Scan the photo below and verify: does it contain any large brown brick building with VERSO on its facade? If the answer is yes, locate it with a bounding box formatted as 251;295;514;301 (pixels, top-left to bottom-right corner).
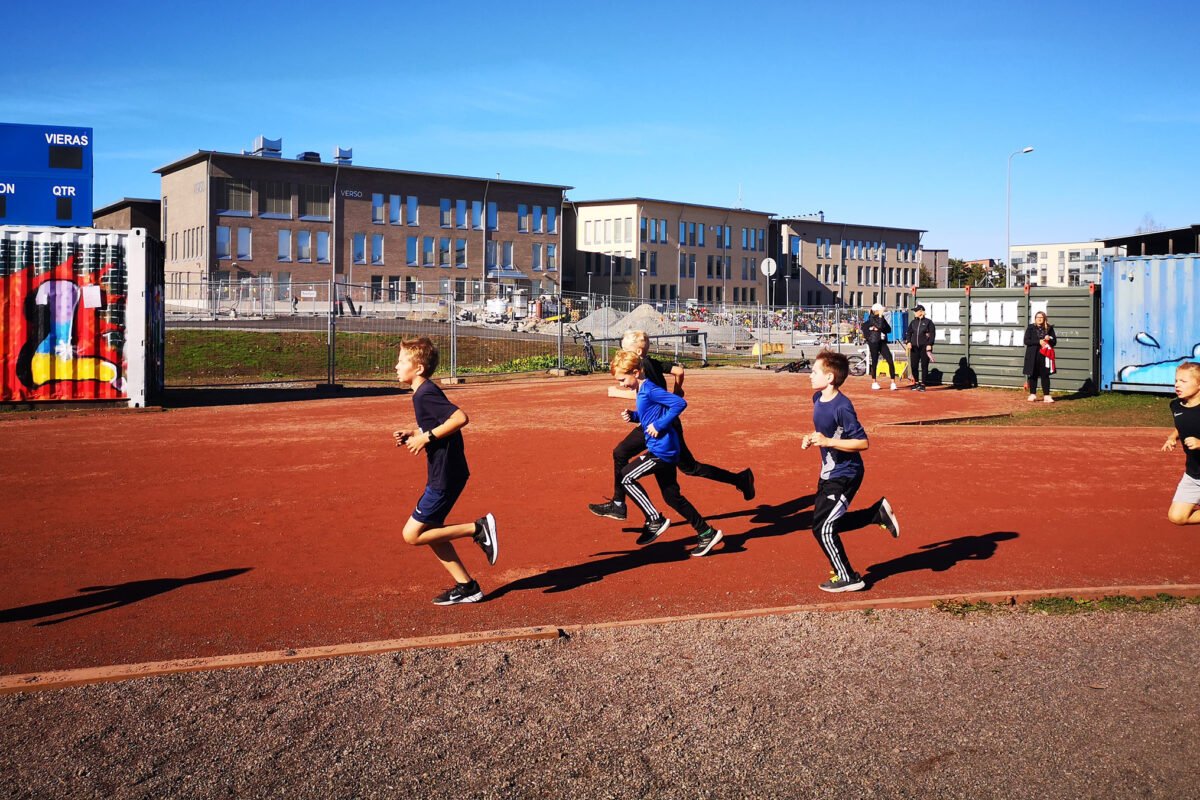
155;137;570;299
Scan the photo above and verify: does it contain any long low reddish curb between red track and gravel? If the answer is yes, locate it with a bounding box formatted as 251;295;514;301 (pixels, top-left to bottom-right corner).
0;583;1200;694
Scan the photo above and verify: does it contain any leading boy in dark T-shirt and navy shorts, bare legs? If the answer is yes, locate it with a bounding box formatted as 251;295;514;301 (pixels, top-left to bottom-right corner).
392;336;498;606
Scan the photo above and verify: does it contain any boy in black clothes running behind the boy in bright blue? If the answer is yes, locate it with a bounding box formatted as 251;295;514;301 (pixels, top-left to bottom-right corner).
588;331;755;519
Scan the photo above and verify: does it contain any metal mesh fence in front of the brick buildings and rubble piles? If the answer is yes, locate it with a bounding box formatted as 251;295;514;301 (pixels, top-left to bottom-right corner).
164;278;899;386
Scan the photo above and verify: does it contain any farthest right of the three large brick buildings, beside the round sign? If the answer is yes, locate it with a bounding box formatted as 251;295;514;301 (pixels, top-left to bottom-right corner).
770;212;925;308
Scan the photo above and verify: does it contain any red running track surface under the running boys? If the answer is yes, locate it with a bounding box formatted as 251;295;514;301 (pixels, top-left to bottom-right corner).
0;369;1200;674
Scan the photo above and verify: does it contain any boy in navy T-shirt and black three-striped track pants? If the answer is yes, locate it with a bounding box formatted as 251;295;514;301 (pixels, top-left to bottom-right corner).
800;350;900;591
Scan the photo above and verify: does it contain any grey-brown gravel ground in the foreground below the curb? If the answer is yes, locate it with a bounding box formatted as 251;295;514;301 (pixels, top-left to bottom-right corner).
0;606;1200;799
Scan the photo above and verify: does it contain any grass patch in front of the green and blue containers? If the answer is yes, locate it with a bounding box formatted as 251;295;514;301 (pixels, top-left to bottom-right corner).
947;389;1171;428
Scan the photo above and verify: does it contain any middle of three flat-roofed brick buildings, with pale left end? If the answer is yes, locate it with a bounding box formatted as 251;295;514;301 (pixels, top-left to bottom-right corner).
565;198;770;305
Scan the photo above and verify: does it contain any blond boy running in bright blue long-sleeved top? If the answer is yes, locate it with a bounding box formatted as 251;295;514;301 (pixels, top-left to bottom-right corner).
610;350;722;557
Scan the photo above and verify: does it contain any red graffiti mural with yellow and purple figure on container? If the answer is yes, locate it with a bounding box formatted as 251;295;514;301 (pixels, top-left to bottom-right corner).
0;254;126;401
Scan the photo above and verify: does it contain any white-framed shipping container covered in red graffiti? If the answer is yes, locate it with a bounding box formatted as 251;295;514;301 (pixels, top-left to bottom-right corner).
0;227;162;407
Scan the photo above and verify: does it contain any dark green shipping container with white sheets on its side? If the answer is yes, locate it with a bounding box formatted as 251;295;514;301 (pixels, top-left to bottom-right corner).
912;284;1100;393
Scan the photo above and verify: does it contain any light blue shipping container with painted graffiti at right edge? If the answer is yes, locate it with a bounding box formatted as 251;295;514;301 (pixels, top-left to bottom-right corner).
1100;253;1200;392
